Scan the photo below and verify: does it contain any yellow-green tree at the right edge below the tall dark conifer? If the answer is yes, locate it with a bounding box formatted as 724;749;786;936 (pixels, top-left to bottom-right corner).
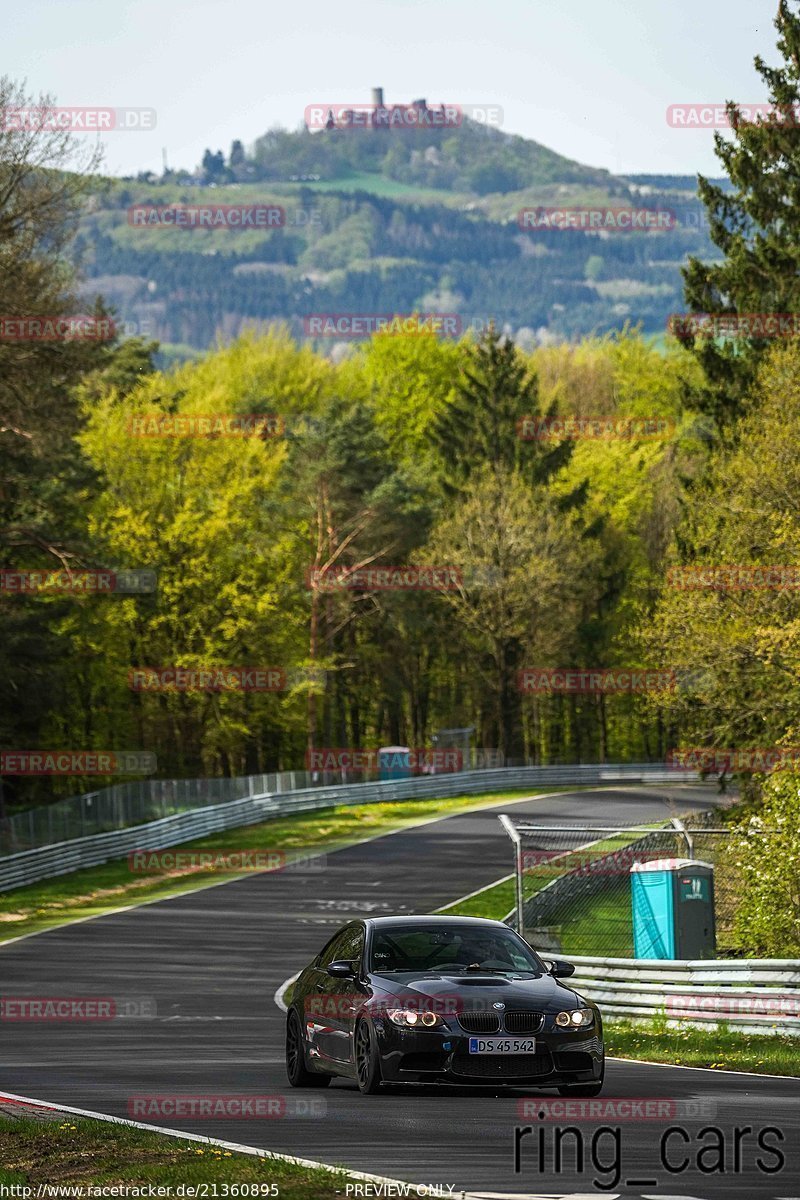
642;343;800;749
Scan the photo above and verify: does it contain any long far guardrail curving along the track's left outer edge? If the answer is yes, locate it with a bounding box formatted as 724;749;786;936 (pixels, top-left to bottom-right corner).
0;763;698;892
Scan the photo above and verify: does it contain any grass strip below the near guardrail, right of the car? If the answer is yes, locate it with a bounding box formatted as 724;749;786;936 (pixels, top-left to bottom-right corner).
603;1018;800;1076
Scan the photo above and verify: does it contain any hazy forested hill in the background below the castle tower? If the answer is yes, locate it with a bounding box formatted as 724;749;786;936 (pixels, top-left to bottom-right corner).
78;102;712;359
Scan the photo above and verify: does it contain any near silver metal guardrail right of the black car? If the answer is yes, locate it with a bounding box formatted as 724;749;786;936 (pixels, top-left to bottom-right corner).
568;952;800;1037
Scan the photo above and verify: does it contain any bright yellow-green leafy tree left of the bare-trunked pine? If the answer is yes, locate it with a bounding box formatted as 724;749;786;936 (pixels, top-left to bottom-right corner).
77;335;332;776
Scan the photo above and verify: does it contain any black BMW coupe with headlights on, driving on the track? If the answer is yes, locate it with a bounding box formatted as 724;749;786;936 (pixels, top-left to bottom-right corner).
287;917;604;1096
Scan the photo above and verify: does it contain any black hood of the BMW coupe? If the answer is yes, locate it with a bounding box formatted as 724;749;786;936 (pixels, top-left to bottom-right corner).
372;971;587;1010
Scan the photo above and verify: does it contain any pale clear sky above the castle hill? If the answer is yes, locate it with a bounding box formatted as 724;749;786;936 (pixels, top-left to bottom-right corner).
0;0;778;175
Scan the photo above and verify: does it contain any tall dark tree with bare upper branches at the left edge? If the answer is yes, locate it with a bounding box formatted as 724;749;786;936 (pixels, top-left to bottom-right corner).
0;78;113;816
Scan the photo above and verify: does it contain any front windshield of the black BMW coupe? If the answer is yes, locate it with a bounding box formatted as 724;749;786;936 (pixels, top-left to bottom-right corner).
369;924;545;974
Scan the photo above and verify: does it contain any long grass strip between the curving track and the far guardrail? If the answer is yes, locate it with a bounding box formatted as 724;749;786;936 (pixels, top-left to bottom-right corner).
0;788;563;943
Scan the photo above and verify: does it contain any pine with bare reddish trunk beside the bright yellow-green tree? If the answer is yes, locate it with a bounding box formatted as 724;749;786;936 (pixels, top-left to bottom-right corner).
285;400;429;749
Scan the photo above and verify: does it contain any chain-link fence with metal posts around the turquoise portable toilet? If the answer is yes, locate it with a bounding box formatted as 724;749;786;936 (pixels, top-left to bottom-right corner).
503;814;741;958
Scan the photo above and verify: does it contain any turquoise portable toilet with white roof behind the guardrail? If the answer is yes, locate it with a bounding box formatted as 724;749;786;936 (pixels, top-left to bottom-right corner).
631;858;716;959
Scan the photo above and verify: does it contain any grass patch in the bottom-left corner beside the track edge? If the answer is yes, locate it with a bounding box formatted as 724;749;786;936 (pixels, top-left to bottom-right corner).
0;1115;349;1200
